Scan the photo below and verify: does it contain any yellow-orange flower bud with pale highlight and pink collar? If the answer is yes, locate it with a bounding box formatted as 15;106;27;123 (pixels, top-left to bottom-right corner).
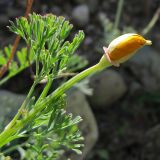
103;33;152;66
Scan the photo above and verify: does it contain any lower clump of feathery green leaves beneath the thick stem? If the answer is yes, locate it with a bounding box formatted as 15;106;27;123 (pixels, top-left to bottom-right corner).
20;96;83;160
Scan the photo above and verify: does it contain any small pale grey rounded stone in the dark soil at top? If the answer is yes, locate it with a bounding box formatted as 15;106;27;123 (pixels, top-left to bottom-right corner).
72;4;89;26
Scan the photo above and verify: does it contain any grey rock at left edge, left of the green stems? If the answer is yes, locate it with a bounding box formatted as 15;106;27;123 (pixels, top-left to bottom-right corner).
0;90;25;125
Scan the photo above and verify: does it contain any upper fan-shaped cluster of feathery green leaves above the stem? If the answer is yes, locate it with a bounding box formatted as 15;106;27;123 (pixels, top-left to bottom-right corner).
9;14;84;80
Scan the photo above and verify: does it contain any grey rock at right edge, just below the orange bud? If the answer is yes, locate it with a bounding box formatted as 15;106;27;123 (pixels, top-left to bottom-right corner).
126;47;160;91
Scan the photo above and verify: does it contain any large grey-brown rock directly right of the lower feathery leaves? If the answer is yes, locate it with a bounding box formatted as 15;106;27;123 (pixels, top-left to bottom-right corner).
67;89;98;160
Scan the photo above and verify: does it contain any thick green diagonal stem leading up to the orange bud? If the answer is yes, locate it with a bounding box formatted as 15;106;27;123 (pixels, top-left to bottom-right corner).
0;56;111;147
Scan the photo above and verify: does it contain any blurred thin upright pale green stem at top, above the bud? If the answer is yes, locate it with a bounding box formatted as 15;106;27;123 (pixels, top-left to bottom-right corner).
114;0;124;30
